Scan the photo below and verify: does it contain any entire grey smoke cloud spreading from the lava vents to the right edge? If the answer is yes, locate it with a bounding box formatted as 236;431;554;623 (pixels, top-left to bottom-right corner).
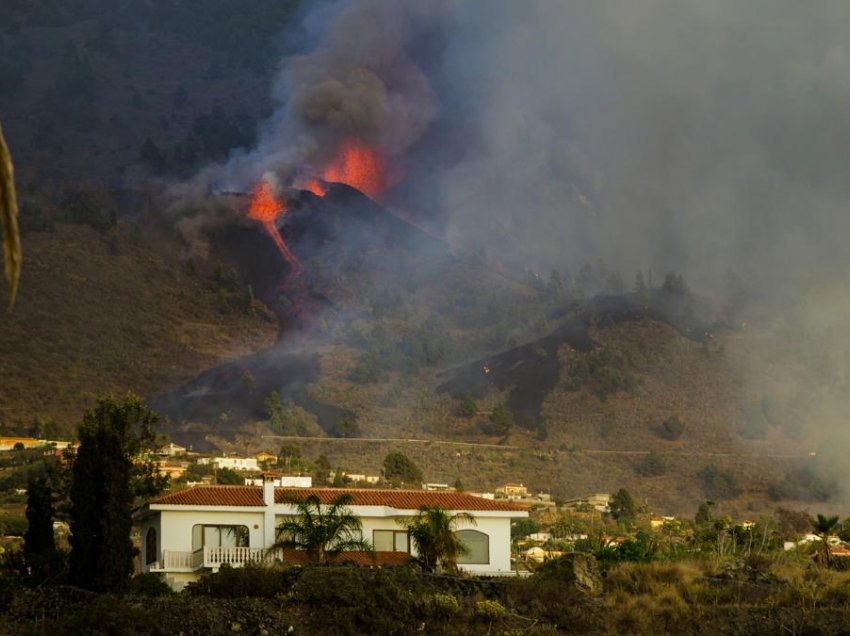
184;0;850;496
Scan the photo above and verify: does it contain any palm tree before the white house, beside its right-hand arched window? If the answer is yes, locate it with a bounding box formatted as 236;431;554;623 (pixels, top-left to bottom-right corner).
402;506;476;572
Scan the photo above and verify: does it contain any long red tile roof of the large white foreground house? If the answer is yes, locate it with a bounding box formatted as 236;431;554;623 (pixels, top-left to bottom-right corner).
151;486;528;511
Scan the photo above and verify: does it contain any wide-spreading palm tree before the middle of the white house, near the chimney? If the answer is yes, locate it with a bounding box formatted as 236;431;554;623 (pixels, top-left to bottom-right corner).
271;494;372;563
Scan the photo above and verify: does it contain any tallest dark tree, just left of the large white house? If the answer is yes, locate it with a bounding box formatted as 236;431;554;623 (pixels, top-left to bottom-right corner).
69;394;164;591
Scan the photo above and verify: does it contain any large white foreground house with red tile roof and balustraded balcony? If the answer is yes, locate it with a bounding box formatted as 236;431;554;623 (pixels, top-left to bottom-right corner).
137;482;528;589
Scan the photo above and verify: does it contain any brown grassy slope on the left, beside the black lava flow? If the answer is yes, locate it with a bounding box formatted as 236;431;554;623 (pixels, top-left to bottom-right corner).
0;220;275;430
